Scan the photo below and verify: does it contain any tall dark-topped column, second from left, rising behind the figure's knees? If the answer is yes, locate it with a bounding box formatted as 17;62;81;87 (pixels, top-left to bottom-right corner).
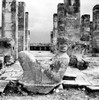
18;2;25;52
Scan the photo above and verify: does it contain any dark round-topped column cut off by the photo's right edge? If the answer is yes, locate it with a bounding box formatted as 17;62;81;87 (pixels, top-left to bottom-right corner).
92;5;99;53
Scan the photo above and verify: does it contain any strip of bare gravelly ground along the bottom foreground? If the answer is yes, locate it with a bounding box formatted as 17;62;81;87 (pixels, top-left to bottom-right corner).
0;89;99;100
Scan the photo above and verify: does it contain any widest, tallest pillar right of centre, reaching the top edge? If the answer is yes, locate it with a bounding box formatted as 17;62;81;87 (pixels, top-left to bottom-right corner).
64;0;80;41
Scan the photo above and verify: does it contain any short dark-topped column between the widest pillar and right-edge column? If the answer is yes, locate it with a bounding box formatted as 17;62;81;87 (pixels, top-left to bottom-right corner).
80;14;90;41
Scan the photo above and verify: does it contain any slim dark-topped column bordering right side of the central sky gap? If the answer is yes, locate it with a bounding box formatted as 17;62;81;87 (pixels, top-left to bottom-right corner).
53;13;58;53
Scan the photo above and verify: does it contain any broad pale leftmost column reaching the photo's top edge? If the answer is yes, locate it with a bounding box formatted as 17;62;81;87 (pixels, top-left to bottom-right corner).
1;0;18;59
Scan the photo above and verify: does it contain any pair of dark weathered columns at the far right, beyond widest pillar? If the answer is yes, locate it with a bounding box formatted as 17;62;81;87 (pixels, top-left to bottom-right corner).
81;5;99;53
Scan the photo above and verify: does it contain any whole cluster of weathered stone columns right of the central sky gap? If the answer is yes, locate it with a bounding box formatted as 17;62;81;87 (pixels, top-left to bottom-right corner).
51;0;99;52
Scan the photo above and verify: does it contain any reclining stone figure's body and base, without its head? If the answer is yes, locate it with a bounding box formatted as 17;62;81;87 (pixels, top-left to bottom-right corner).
19;42;69;93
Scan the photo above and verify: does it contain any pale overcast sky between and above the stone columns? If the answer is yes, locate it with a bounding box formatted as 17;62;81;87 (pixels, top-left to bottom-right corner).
0;0;99;43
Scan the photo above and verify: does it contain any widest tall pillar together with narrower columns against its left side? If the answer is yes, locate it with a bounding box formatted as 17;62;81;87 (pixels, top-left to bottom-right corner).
53;0;80;51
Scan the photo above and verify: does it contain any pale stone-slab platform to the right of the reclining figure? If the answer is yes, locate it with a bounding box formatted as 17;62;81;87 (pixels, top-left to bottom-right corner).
63;57;99;90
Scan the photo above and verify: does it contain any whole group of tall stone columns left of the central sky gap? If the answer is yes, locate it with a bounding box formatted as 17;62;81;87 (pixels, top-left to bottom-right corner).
1;0;30;59
